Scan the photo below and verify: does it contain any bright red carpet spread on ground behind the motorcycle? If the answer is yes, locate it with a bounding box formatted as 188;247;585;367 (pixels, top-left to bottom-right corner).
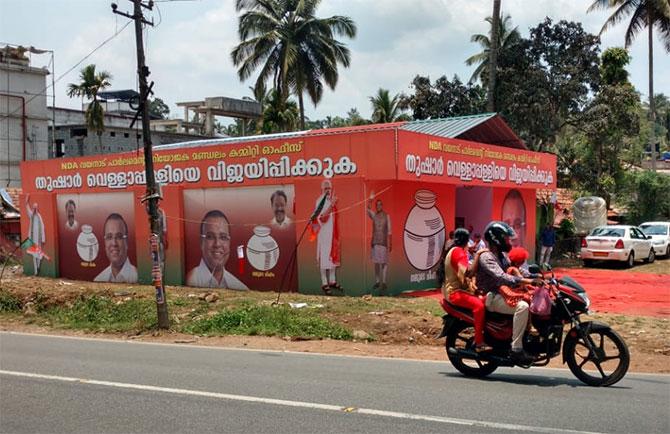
403;268;670;317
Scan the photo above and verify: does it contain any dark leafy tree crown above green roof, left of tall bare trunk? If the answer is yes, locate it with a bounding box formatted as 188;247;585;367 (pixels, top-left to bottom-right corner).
399;75;486;119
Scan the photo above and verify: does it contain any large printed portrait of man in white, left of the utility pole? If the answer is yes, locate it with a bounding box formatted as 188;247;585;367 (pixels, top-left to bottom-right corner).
93;213;137;283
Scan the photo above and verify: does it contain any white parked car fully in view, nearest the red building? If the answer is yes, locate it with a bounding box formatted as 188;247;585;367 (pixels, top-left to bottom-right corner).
580;225;656;267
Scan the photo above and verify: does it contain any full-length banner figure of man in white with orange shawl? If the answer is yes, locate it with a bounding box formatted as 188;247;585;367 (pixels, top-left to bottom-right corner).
312;179;342;295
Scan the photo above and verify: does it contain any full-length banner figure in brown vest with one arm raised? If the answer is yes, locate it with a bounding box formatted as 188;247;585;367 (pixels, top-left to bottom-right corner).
368;199;392;295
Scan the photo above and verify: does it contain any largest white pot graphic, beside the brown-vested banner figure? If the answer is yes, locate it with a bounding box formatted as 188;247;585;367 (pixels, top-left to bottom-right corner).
404;190;445;271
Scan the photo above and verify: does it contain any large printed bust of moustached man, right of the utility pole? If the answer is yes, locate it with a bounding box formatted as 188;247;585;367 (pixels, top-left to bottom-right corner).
186;210;249;290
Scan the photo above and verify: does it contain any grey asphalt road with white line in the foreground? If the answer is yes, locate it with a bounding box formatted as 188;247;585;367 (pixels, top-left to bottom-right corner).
0;333;670;433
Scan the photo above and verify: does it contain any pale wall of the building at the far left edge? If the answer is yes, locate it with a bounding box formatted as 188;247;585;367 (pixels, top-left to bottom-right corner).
0;62;49;187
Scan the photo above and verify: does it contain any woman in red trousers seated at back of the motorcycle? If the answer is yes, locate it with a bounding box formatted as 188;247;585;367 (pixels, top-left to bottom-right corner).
437;228;493;352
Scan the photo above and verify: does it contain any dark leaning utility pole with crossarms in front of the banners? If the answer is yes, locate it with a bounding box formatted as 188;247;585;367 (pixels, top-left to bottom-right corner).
112;0;170;329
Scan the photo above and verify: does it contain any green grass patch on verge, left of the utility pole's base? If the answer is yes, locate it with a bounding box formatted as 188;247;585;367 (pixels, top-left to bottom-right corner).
45;295;156;332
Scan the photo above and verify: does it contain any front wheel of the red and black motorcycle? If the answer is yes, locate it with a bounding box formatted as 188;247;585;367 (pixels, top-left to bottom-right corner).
563;325;630;387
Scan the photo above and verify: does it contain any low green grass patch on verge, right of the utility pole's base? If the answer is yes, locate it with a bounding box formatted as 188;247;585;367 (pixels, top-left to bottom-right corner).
183;304;353;340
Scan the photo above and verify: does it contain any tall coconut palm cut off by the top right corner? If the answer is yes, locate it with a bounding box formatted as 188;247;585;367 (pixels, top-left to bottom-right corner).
588;0;670;170
